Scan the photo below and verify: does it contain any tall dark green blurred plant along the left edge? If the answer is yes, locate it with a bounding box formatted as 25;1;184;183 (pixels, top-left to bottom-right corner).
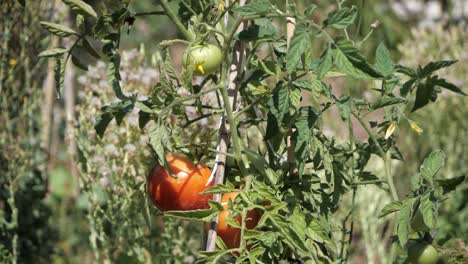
0;1;57;263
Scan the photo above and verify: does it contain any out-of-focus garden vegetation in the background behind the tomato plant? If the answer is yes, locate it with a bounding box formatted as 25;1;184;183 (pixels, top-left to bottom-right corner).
0;0;468;263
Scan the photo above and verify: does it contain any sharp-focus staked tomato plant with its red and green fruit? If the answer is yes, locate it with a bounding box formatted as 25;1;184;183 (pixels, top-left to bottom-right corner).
37;0;466;263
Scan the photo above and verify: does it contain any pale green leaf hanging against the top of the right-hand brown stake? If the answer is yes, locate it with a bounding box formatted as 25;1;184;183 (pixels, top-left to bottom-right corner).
286;24;311;73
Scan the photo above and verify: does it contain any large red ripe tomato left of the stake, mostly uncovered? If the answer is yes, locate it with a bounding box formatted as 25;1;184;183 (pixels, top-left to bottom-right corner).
148;153;214;211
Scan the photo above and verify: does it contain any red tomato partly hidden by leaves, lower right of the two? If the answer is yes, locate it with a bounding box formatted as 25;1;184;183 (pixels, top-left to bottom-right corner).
217;192;260;248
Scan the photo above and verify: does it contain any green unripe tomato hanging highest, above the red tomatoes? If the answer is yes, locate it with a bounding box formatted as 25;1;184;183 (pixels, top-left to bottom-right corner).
182;44;223;76
